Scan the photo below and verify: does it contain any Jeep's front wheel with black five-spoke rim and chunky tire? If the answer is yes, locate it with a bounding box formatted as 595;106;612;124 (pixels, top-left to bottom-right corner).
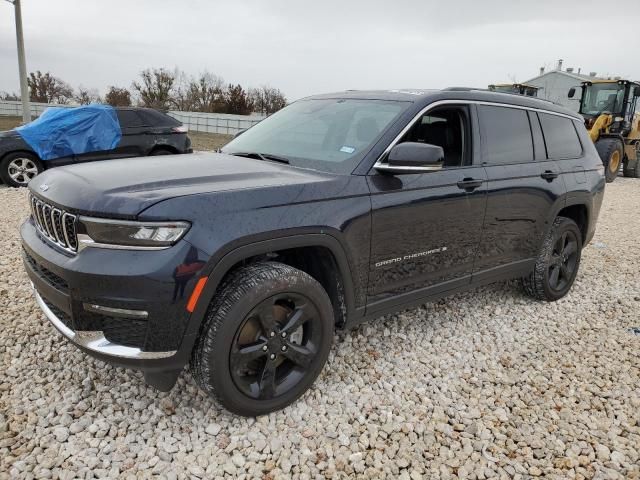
191;262;335;416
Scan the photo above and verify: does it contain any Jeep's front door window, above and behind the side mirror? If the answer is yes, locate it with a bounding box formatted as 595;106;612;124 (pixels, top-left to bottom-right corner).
398;107;471;168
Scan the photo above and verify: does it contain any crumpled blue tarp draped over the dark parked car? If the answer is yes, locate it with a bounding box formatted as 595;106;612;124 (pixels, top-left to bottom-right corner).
16;105;122;160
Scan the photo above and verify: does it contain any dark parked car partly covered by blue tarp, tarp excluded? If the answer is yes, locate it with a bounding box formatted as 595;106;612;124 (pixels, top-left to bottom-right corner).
0;107;193;187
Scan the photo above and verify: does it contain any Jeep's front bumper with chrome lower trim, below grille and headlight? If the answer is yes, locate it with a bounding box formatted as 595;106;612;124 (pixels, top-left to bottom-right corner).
21;219;204;376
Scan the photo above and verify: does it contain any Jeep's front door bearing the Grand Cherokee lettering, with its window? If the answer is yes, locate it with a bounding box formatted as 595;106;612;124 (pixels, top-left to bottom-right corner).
367;105;487;313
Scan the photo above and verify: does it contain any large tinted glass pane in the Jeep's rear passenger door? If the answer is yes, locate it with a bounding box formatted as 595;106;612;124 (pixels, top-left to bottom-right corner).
478;105;533;164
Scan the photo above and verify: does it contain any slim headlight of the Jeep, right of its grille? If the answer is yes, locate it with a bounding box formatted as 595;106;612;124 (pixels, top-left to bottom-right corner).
78;217;191;250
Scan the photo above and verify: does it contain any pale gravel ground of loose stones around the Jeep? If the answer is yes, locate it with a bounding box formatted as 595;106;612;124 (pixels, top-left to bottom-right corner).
0;178;640;480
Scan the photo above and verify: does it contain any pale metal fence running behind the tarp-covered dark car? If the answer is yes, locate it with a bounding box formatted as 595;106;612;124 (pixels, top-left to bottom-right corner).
0;100;265;135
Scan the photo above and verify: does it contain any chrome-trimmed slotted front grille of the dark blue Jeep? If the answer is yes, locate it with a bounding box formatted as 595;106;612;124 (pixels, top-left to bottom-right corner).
29;194;78;253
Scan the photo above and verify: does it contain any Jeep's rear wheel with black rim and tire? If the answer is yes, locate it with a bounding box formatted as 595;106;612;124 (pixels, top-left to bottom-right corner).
522;217;582;302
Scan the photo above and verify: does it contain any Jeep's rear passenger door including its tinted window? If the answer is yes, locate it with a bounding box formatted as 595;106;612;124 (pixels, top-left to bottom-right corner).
473;105;566;282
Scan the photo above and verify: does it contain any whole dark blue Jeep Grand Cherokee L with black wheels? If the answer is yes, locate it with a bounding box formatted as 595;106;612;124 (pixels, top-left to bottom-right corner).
21;89;605;415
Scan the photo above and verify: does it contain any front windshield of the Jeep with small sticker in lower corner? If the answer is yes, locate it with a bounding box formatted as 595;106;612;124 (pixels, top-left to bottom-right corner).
222;99;409;173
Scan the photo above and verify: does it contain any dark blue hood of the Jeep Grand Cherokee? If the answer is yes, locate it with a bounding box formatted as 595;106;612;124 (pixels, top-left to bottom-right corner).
29;152;327;218
